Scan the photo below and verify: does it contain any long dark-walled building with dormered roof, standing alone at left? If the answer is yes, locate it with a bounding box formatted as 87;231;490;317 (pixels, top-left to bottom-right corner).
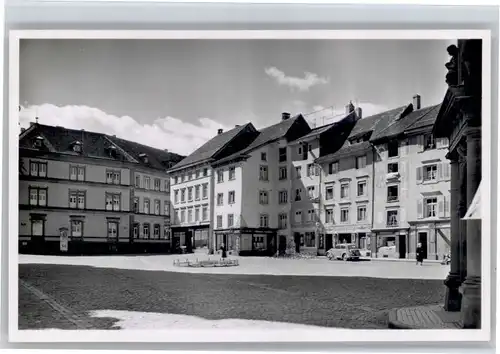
19;123;183;253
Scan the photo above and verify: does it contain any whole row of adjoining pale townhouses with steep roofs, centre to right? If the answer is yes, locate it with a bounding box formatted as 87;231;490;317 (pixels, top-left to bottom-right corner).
169;95;450;258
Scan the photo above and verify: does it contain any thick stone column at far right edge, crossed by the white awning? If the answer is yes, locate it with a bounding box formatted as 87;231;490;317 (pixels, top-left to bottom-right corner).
462;127;481;328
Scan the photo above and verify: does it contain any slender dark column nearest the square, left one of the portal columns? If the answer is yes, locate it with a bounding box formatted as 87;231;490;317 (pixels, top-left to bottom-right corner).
444;155;462;311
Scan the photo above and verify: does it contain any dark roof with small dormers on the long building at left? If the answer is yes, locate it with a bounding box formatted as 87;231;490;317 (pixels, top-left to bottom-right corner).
19;124;186;170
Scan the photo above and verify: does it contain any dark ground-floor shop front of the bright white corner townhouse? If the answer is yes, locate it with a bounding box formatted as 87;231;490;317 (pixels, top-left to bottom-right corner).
211;228;280;256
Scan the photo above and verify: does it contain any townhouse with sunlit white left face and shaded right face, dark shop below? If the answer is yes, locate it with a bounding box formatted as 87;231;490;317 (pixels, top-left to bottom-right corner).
208;113;311;255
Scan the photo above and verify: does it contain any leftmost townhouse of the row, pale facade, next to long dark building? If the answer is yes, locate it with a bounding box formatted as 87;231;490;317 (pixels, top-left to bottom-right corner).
169;123;257;252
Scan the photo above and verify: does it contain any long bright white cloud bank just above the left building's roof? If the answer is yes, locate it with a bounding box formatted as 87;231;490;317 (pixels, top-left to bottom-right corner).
19;103;231;155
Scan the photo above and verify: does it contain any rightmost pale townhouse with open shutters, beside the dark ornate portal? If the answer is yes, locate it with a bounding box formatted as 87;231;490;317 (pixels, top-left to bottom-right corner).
370;95;450;259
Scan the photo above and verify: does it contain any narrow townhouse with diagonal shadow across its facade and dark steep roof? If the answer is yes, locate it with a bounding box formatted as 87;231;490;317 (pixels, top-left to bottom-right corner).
290;104;361;255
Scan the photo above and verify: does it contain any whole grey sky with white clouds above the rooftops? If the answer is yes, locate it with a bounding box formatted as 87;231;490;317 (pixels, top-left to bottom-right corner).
20;39;449;154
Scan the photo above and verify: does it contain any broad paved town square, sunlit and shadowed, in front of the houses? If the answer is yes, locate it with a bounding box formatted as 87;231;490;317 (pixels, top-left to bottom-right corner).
19;255;449;329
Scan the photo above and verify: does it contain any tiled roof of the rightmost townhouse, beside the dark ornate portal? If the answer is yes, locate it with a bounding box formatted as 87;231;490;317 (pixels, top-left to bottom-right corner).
370;105;439;141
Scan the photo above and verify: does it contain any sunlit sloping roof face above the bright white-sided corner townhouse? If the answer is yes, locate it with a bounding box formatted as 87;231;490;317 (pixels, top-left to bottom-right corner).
210;114;307;167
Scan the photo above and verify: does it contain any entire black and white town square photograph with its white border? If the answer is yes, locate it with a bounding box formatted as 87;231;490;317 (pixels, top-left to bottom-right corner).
8;31;491;341
